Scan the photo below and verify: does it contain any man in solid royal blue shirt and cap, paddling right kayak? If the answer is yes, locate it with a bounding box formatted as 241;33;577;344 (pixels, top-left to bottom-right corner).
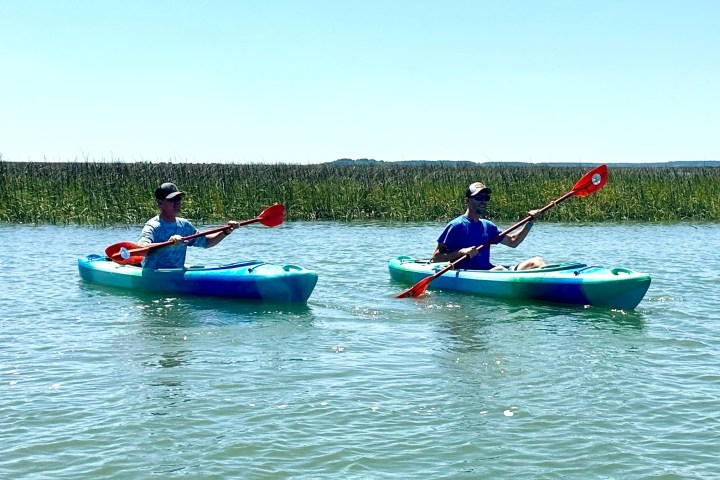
432;182;545;270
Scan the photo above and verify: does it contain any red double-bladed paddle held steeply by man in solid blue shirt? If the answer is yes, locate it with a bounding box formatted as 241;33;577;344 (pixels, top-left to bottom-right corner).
395;165;607;298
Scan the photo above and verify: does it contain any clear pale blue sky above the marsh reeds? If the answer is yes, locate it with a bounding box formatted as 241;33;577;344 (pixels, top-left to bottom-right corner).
0;0;720;163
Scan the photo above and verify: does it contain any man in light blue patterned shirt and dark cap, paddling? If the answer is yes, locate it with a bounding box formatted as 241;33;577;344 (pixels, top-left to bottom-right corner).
138;182;238;269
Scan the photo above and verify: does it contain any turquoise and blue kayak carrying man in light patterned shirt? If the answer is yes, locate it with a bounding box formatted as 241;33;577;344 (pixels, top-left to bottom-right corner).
78;254;318;303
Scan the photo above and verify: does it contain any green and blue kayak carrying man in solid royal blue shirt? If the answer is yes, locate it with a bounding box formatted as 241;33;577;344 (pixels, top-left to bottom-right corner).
388;256;651;310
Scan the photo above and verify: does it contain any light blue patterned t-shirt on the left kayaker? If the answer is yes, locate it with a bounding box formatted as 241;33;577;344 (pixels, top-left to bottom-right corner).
138;215;207;269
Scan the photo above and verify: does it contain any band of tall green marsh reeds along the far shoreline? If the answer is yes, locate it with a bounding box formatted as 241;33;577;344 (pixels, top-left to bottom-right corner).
0;157;720;226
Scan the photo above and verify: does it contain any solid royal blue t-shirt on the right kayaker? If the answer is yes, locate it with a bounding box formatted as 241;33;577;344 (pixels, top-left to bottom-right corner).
438;215;502;270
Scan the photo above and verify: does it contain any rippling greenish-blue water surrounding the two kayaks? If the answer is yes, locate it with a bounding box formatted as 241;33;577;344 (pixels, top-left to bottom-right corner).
0;223;720;479
